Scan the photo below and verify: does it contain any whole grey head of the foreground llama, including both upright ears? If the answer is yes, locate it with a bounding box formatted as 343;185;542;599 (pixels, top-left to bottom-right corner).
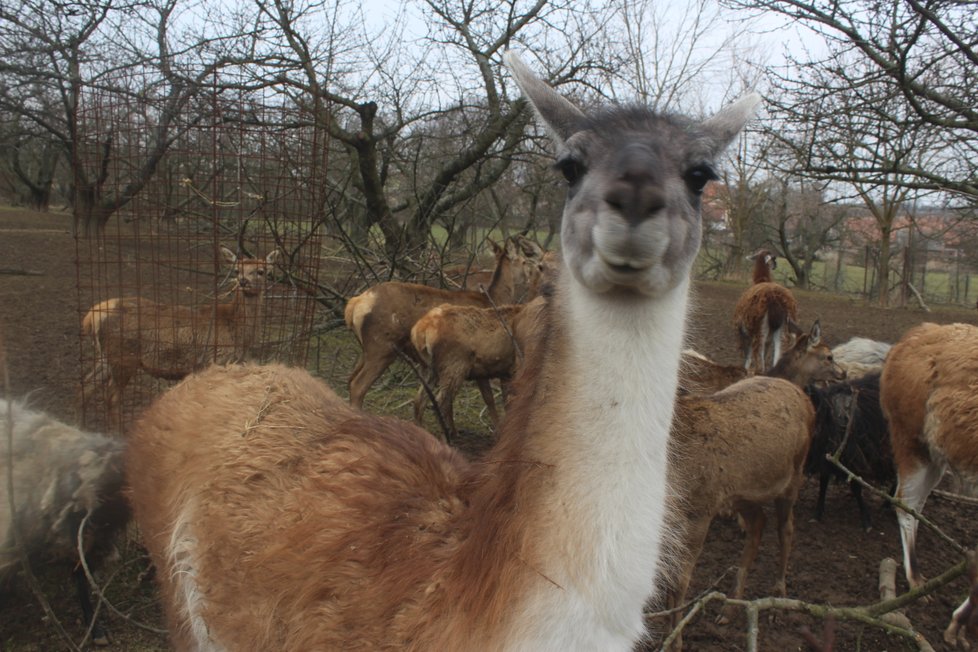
506;52;760;296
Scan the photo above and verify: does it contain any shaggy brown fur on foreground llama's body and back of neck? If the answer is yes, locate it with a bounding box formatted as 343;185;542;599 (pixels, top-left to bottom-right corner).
127;292;563;650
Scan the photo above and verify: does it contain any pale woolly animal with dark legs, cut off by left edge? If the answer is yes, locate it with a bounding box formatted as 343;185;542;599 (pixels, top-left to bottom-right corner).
0;400;129;644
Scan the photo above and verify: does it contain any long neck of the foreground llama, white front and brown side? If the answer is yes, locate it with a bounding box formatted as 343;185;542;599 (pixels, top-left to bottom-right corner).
472;279;687;649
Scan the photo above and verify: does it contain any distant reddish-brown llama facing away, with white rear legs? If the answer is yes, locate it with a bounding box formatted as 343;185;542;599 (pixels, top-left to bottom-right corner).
734;249;798;373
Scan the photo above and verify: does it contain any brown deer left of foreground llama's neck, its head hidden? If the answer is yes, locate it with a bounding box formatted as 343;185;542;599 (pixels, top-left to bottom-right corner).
411;297;545;441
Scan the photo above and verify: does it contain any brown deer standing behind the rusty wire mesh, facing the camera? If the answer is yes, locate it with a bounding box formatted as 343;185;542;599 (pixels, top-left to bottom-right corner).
82;247;279;422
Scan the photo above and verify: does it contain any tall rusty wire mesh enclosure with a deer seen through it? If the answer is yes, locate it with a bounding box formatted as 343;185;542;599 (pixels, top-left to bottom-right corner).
76;85;328;432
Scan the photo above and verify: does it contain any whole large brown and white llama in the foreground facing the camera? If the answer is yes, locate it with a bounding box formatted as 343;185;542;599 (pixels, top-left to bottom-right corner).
127;54;759;650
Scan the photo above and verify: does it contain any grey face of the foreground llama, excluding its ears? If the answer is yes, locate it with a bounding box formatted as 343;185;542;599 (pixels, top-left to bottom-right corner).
557;114;715;296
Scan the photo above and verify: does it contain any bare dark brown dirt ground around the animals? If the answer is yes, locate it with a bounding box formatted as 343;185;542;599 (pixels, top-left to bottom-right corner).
0;208;978;652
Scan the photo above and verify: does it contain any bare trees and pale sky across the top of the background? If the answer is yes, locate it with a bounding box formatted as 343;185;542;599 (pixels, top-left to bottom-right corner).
0;0;978;304
